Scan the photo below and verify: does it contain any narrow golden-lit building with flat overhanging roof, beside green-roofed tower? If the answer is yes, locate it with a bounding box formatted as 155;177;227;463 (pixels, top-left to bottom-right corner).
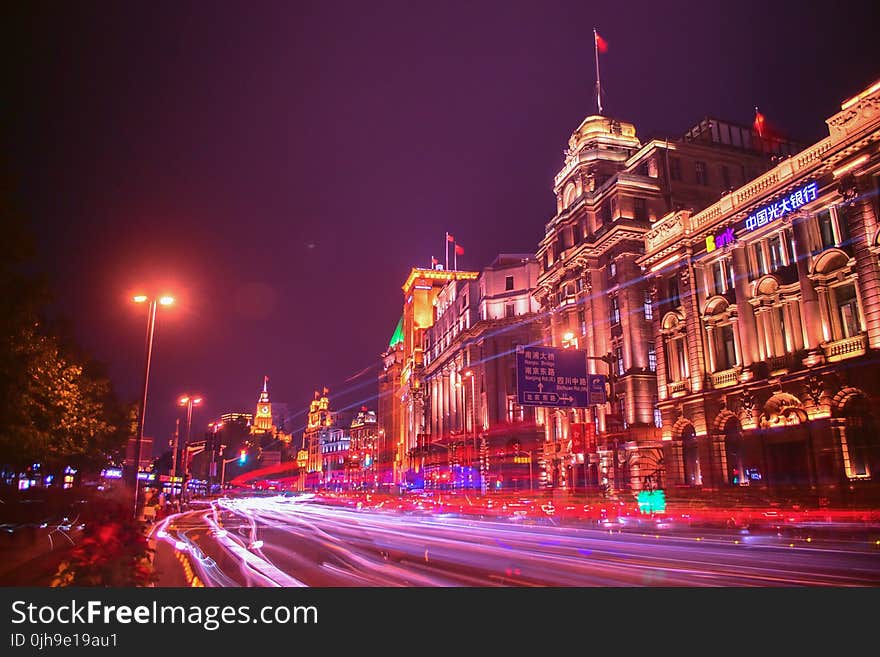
386;268;477;484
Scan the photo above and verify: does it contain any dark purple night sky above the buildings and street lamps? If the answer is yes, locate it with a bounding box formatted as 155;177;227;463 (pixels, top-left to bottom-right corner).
0;0;880;448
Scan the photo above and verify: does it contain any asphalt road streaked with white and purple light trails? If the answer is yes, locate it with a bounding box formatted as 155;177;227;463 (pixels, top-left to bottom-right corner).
154;497;880;587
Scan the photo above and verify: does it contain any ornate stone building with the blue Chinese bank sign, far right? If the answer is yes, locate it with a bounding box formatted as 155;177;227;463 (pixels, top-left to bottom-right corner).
639;78;880;497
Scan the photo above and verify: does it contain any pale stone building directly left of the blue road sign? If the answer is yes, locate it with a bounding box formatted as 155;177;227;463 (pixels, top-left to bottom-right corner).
422;254;542;489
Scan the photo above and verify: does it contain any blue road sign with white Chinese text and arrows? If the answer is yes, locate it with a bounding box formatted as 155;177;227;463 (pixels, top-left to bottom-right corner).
516;347;605;408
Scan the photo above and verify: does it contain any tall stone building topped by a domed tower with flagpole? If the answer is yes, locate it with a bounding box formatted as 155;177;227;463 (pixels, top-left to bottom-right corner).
535;111;797;489
